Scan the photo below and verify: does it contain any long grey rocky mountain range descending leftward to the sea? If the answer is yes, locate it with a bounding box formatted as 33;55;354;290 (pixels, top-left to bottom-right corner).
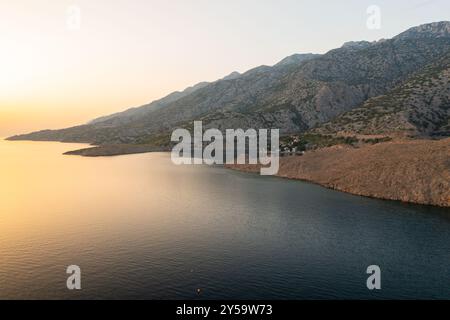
6;22;450;145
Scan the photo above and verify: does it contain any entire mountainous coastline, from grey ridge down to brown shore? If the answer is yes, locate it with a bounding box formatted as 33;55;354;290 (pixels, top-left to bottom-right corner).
8;21;450;207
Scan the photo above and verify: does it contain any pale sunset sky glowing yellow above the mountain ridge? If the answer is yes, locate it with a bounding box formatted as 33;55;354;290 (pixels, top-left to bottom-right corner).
0;0;450;137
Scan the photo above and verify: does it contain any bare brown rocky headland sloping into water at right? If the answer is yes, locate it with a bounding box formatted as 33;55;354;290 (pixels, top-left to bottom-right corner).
230;139;450;207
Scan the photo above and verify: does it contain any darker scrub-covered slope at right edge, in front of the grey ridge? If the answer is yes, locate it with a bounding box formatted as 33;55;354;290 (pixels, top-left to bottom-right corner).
313;53;450;137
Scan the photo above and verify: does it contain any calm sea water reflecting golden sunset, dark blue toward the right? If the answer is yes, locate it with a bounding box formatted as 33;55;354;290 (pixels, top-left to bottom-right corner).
0;141;450;299
